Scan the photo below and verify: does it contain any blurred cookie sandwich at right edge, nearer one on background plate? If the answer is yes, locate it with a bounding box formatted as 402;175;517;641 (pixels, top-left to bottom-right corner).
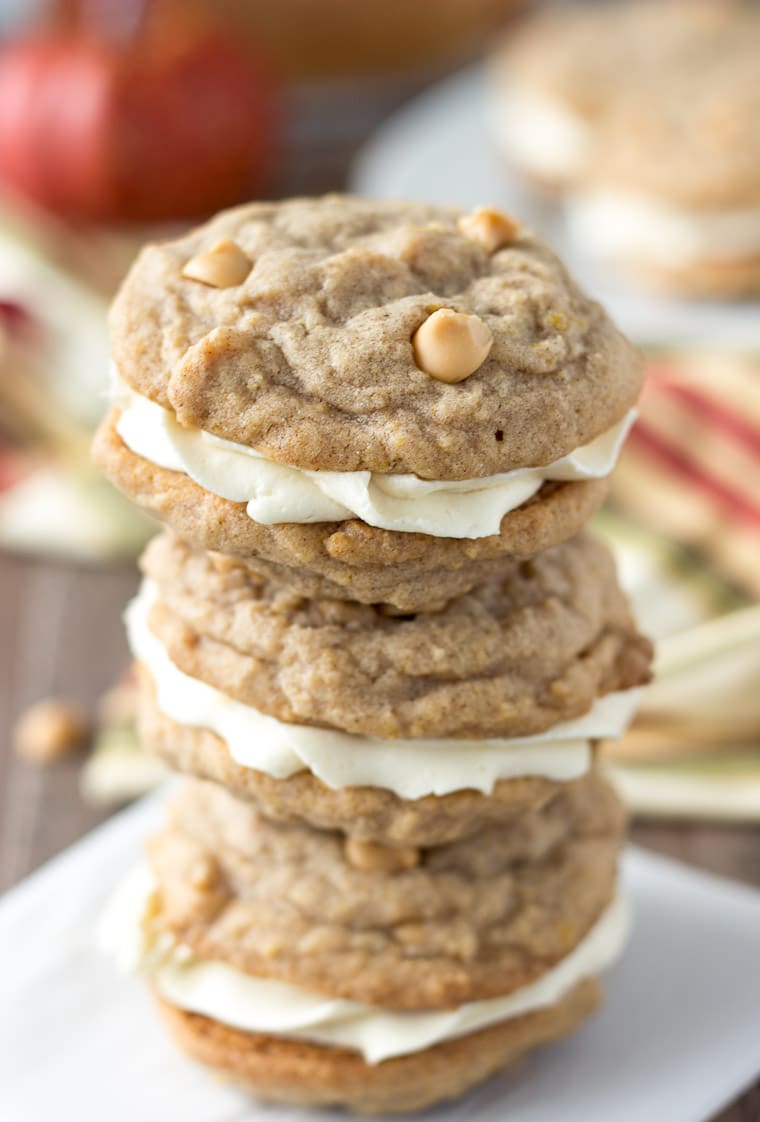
567;19;760;297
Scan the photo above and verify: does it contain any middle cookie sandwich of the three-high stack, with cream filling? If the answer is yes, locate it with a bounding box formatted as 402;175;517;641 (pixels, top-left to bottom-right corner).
127;533;651;846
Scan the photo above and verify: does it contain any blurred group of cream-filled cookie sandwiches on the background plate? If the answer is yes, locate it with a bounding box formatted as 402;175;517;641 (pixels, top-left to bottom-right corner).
491;0;760;297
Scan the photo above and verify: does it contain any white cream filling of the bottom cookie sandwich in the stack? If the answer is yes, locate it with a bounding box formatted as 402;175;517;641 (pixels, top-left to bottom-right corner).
98;866;630;1064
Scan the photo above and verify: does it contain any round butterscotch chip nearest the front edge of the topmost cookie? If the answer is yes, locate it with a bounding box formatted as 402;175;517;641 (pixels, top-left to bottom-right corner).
412;307;494;383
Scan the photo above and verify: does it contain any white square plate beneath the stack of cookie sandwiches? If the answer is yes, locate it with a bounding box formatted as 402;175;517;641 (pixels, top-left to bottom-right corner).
0;797;760;1122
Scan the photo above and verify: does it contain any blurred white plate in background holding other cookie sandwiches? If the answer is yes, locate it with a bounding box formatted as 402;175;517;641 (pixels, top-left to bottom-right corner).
351;66;760;347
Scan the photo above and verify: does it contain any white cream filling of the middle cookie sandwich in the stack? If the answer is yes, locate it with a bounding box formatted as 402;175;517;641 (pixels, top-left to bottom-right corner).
125;580;639;799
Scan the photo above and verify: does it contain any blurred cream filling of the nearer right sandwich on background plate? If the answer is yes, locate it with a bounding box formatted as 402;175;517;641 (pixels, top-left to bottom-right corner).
567;191;760;267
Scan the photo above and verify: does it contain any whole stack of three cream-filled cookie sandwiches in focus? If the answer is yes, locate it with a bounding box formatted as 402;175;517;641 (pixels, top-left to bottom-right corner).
95;196;651;1112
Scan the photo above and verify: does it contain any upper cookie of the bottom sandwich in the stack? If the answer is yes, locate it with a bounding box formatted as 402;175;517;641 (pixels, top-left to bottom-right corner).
143;774;623;1010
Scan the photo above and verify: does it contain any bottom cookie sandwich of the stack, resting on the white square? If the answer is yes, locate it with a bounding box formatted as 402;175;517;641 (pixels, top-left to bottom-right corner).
101;776;628;1113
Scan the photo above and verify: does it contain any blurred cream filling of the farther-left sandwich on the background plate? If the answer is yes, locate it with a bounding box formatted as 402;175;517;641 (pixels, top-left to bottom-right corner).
489;82;592;180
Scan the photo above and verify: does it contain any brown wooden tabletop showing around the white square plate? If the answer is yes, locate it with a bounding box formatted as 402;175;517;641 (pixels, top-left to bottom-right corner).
0;554;760;1122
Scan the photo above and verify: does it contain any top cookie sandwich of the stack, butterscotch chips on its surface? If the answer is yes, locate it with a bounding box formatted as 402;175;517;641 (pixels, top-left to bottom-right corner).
94;196;641;604
